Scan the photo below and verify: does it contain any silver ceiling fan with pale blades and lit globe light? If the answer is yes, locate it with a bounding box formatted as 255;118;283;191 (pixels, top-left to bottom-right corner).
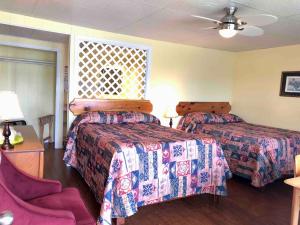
192;6;278;38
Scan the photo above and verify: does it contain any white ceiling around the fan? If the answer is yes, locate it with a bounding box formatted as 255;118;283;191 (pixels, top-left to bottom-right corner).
0;0;300;51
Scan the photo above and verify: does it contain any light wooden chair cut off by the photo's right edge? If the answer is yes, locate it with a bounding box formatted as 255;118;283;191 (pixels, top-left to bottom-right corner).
284;155;300;225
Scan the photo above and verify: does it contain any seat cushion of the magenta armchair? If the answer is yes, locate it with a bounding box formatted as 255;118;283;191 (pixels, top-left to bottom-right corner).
28;188;96;225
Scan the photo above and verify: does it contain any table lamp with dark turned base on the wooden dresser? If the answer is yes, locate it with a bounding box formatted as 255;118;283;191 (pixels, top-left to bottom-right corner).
0;91;24;150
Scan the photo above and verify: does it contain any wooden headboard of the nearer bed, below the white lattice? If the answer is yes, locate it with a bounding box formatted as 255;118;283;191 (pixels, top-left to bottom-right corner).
69;98;153;116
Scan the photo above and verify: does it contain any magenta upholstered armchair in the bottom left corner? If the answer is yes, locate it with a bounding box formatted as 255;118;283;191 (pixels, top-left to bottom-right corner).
0;151;96;225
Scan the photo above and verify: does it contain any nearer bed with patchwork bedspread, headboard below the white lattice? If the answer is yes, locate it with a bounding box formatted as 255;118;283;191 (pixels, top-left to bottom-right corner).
64;99;231;225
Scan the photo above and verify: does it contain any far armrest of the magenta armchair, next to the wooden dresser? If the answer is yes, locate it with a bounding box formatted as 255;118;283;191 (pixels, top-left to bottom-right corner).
0;154;62;200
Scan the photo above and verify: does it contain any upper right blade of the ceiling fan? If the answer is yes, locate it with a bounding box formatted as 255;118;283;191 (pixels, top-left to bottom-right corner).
239;14;278;27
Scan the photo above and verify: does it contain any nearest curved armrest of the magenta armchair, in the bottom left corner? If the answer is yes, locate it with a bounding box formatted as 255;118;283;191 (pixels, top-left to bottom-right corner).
0;181;76;225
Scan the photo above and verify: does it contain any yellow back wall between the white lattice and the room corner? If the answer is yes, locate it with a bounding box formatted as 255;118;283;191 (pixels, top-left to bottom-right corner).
148;42;234;124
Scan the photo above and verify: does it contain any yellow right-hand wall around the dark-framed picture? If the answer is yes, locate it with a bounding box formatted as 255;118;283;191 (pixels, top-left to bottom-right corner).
232;45;300;131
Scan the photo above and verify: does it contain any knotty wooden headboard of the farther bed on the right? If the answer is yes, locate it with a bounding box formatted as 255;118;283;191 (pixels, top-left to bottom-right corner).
176;102;231;116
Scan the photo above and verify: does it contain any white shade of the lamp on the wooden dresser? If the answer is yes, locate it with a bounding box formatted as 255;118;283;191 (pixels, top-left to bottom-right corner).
0;91;24;121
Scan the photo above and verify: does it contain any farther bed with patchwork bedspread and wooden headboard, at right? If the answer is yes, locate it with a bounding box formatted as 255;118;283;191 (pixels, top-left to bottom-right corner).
176;102;300;187
